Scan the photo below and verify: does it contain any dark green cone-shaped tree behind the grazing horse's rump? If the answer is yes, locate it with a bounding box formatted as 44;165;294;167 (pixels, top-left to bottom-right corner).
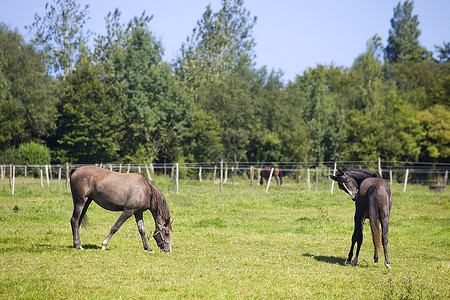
56;55;124;163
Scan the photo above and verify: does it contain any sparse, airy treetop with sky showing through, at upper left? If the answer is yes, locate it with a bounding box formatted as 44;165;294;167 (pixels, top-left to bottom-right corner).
26;0;89;80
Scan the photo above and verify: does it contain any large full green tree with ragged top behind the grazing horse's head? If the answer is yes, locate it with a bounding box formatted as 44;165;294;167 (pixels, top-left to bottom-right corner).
95;10;192;162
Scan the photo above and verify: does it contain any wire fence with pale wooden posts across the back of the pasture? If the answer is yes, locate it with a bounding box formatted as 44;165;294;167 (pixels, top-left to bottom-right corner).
0;160;450;194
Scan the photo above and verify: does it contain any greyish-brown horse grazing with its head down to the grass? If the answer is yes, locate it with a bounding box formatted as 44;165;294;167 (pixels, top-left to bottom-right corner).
70;166;172;252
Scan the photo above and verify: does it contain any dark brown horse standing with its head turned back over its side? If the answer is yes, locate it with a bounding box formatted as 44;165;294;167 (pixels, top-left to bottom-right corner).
330;168;392;268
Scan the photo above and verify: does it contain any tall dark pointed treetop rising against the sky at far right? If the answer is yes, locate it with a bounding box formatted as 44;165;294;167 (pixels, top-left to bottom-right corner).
386;0;431;63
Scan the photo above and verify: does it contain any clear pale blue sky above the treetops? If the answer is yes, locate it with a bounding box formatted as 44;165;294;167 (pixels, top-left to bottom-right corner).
0;0;450;80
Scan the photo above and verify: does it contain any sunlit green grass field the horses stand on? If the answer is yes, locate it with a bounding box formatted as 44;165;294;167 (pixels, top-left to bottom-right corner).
0;178;450;299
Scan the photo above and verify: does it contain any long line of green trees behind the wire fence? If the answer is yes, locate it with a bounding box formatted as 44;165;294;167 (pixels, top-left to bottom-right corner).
0;0;450;163
